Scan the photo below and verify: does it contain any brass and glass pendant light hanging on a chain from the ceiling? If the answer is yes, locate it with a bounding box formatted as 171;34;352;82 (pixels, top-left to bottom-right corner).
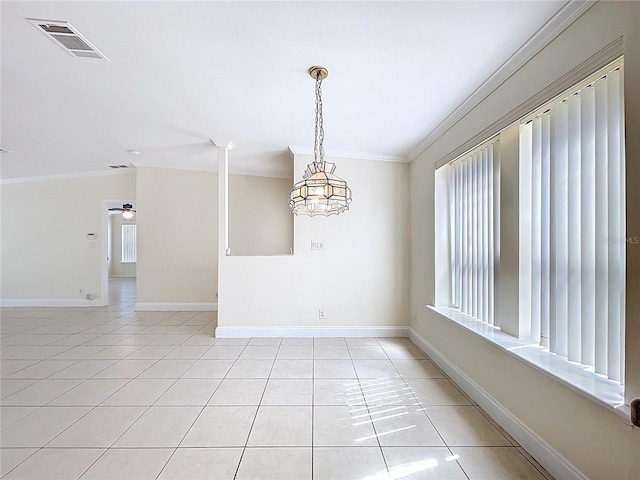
289;67;351;217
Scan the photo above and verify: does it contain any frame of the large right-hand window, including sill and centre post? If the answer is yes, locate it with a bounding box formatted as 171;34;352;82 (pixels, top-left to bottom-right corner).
427;53;630;424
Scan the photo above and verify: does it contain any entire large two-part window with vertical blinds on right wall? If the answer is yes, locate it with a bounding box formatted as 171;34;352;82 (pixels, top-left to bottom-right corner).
435;59;626;384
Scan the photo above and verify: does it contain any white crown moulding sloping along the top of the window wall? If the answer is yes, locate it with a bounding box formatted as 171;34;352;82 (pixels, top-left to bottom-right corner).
407;0;596;161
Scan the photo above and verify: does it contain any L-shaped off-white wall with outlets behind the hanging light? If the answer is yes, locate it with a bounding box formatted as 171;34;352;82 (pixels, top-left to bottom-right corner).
218;152;409;330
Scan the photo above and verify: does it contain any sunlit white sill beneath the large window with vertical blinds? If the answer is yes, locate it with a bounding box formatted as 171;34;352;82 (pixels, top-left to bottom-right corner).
427;305;631;425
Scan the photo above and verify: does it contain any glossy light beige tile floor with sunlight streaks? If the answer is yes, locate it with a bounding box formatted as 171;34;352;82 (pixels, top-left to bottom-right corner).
0;280;551;480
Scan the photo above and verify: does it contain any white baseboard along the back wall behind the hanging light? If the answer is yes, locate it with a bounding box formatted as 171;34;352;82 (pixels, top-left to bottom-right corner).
216;326;409;338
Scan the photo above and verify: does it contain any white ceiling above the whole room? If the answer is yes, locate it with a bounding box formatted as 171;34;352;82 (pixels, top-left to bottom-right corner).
0;0;568;180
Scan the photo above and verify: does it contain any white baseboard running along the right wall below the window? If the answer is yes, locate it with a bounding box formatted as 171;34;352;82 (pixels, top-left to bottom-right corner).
409;328;587;480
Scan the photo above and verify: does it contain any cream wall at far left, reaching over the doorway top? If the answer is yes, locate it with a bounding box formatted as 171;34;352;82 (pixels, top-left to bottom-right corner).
0;174;136;301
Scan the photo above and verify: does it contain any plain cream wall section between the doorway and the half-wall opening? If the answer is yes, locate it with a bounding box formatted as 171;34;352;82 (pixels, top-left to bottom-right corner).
136;167;218;309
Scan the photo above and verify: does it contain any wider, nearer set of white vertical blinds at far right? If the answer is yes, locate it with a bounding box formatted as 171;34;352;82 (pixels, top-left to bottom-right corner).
521;62;626;382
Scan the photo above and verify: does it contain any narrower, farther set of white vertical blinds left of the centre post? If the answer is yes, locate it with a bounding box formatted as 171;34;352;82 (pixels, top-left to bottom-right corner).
448;140;498;325
